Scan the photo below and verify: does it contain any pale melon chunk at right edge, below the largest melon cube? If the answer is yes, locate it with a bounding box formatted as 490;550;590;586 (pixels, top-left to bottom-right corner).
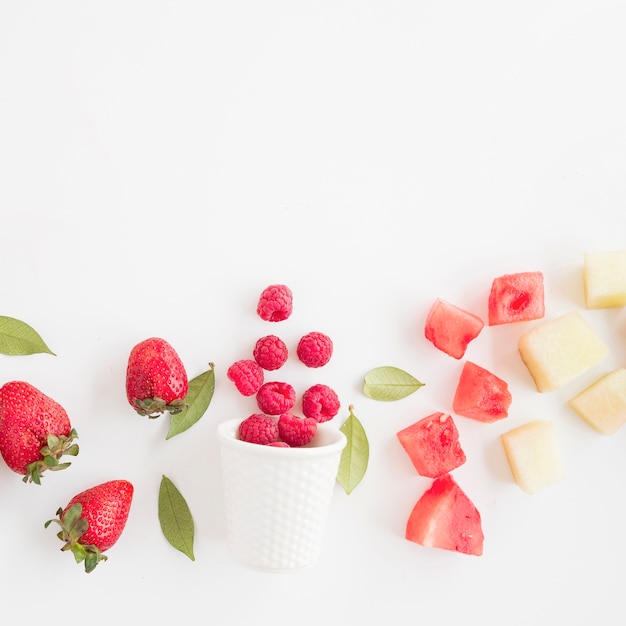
568;367;626;435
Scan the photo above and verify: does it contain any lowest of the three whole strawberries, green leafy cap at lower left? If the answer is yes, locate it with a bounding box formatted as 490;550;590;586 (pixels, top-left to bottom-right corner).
44;480;134;573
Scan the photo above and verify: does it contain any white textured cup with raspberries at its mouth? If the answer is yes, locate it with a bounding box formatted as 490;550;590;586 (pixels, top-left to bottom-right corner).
218;419;346;571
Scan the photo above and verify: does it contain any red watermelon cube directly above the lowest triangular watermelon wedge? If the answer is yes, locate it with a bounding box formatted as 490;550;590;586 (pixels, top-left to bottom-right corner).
396;411;466;478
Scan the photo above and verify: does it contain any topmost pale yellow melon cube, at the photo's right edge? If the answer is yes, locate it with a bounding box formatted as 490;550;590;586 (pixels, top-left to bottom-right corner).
583;250;626;309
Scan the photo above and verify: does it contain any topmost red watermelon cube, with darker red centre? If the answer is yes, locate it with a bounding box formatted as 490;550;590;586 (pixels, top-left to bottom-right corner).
488;272;545;326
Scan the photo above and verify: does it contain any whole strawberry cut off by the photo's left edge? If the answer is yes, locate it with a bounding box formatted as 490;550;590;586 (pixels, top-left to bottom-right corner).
0;381;78;485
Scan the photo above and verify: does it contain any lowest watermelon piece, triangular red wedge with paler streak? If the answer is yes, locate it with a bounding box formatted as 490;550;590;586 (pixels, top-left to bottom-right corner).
405;474;484;556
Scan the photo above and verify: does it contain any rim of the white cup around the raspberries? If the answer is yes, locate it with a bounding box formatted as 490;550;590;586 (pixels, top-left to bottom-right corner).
217;418;348;458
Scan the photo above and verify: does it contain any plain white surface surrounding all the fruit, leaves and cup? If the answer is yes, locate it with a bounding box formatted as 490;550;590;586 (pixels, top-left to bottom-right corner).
0;0;626;625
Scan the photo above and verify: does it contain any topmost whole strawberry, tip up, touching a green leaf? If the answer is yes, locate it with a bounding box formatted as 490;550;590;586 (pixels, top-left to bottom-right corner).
126;337;189;417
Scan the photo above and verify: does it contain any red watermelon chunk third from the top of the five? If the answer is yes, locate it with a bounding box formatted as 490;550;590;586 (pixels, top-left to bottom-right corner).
452;361;512;422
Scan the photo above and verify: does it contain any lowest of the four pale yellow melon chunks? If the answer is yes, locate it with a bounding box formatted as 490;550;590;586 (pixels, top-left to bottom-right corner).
500;420;564;494
